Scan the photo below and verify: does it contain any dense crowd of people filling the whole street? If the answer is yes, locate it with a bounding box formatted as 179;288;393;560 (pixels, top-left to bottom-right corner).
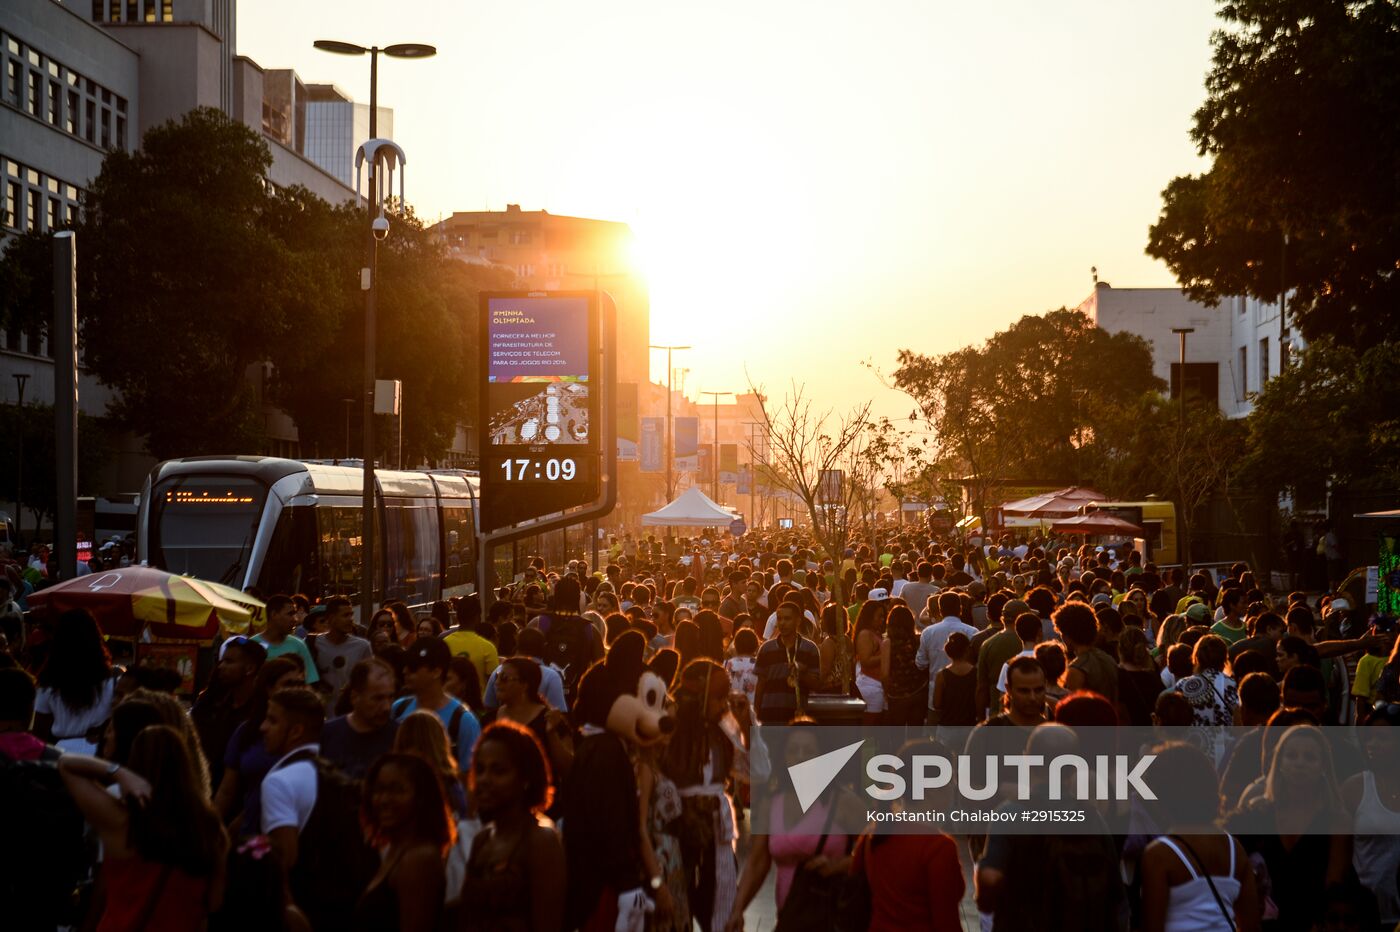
0;529;1400;932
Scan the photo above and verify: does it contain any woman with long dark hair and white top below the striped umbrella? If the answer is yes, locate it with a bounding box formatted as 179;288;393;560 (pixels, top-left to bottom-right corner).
34;610;116;754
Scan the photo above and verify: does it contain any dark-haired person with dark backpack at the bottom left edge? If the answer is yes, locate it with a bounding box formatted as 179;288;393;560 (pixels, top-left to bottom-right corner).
0;668;97;932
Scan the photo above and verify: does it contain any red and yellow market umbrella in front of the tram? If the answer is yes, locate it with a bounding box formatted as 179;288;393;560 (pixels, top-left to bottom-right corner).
29;567;252;641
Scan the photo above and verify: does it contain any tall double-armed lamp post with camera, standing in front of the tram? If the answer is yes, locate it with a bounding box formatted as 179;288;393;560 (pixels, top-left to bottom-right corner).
312;39;437;623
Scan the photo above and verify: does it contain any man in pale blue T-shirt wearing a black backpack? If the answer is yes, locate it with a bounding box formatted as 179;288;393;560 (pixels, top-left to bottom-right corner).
262;687;378;932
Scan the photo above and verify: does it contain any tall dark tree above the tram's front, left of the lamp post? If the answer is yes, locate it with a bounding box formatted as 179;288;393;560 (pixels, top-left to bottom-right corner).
78;108;307;459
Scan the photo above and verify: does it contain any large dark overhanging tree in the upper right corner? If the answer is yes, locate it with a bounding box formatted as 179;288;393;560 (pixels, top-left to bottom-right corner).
1147;0;1400;348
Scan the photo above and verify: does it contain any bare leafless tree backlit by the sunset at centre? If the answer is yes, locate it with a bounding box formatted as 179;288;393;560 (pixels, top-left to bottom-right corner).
749;382;871;563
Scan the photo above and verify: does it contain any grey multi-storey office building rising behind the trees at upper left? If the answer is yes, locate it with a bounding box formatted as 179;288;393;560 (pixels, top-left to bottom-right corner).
0;0;386;490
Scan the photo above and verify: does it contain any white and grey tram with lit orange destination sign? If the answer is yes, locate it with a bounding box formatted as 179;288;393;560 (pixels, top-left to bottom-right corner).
137;456;480;606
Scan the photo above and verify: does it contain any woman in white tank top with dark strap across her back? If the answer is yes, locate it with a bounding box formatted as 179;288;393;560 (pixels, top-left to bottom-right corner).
1138;743;1260;932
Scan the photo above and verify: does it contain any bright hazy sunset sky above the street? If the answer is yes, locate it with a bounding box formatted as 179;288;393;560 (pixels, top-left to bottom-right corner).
238;0;1215;414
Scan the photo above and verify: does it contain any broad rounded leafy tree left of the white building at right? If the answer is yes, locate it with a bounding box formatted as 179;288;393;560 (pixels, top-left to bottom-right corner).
893;308;1163;514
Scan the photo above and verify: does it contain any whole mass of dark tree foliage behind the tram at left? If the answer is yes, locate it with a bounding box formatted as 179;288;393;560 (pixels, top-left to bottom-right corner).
0;109;511;463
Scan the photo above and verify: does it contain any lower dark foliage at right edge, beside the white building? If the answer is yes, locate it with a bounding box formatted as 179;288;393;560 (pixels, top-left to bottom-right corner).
1246;340;1400;504
